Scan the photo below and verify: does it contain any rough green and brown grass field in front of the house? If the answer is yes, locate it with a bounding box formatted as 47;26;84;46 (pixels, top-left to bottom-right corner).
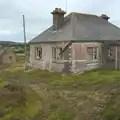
0;55;120;120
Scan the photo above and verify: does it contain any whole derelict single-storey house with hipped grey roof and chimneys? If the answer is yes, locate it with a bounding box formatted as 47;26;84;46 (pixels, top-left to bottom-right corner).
29;8;120;73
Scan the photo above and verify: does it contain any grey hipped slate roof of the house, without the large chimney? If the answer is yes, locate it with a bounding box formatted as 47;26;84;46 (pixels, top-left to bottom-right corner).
30;12;120;43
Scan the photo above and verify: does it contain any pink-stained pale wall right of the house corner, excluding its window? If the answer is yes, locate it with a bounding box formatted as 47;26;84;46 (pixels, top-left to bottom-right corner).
72;42;102;73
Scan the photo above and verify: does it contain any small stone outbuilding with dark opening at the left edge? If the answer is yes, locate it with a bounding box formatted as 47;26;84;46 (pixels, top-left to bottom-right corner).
0;47;16;65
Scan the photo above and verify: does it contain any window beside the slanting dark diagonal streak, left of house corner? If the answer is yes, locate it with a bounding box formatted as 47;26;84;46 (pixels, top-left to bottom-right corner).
52;47;62;60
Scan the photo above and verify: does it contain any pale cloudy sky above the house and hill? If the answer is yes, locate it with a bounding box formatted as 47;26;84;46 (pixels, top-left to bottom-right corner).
0;0;120;42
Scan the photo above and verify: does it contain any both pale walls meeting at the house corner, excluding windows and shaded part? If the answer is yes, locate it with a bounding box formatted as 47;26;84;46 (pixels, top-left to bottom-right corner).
30;42;102;73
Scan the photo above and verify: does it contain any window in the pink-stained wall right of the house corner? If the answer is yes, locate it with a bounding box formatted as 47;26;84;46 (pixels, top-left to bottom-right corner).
87;47;98;60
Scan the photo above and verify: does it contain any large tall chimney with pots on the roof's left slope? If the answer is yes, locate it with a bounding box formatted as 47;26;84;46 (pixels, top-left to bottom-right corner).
51;8;66;30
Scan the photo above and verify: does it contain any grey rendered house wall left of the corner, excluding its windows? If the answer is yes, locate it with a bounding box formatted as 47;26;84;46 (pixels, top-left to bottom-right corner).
30;42;68;72
